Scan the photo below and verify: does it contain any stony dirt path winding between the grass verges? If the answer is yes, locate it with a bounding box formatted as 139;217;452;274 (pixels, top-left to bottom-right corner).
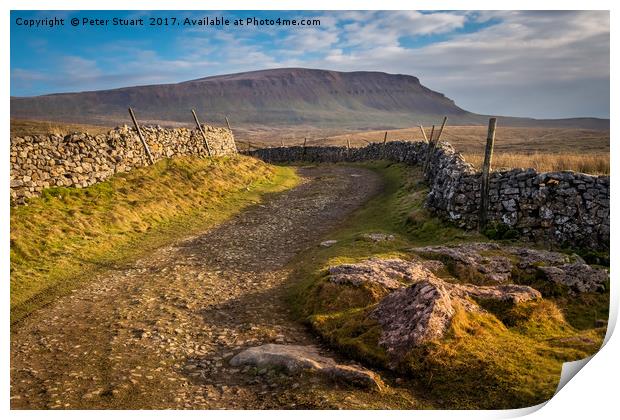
11;166;392;408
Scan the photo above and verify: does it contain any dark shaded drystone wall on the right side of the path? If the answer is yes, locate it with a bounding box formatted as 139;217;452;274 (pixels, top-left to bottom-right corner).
250;141;610;250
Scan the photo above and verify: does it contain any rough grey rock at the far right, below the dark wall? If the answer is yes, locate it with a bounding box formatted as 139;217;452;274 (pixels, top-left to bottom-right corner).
538;262;609;292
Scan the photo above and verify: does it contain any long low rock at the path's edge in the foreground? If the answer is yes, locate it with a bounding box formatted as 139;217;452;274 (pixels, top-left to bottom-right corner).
230;344;383;391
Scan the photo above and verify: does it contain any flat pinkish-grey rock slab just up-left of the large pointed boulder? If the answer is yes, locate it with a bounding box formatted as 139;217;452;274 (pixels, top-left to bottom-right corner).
329;258;434;290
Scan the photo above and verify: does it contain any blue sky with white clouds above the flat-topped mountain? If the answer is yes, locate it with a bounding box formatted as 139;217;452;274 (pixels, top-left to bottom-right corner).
10;11;610;118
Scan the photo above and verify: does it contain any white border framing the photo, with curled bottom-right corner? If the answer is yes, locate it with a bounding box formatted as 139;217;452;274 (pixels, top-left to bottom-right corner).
0;0;620;420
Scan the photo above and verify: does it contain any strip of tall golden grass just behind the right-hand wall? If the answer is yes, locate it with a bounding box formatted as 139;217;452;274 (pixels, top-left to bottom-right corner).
463;153;609;175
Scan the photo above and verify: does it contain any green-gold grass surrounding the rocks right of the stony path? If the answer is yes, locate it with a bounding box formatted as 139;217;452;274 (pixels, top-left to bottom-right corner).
290;163;609;409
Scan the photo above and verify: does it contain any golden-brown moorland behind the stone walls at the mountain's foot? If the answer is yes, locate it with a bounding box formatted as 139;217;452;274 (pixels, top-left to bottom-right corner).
11;119;610;175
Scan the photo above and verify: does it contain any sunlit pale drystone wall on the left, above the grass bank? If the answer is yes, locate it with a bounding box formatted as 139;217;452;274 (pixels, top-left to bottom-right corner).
11;125;237;204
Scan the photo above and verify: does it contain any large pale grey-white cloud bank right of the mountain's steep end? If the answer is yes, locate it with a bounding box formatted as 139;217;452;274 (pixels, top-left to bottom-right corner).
312;12;609;117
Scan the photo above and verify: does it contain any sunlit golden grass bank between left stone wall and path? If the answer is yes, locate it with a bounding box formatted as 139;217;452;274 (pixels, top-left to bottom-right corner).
11;155;298;322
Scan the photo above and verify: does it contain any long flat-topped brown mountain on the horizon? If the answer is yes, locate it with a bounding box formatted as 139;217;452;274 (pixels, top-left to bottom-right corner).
11;68;609;129
